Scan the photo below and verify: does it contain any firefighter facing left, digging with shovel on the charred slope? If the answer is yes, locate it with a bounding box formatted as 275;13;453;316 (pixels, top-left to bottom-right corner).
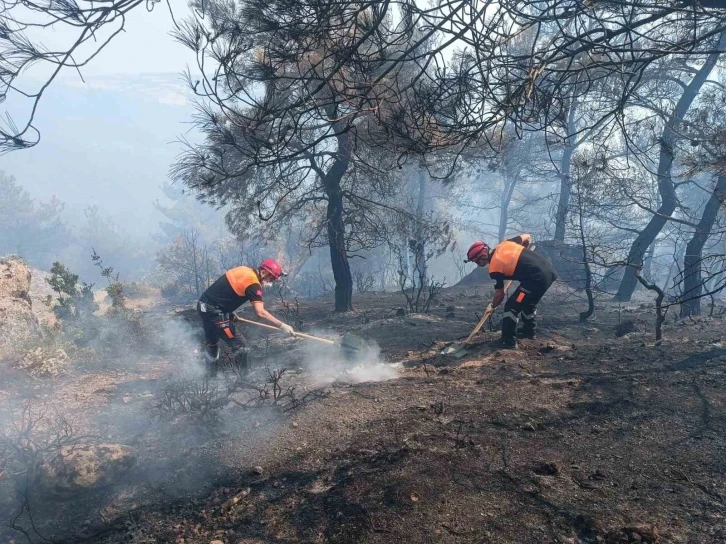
466;234;557;349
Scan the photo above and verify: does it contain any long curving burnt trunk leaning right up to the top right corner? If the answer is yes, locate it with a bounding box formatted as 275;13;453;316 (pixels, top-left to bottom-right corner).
615;33;726;301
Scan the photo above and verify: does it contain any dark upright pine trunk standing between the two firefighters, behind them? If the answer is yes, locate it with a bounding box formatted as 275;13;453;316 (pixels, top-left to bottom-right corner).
323;133;353;312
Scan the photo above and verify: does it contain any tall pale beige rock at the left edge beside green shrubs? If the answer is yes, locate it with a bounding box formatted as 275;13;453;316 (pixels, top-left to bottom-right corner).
0;257;40;360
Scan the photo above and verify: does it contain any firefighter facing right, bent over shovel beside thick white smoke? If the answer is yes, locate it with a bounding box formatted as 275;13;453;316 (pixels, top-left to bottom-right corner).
197;259;295;374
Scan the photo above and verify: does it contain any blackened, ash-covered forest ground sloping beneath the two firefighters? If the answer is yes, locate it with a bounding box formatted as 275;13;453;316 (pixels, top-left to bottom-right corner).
3;290;726;544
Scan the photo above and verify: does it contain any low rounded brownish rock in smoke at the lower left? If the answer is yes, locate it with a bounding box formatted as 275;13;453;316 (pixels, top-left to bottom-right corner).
37;444;138;495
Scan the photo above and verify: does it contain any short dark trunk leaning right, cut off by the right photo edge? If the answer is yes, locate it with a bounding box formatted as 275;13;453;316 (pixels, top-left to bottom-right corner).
681;176;726;317
